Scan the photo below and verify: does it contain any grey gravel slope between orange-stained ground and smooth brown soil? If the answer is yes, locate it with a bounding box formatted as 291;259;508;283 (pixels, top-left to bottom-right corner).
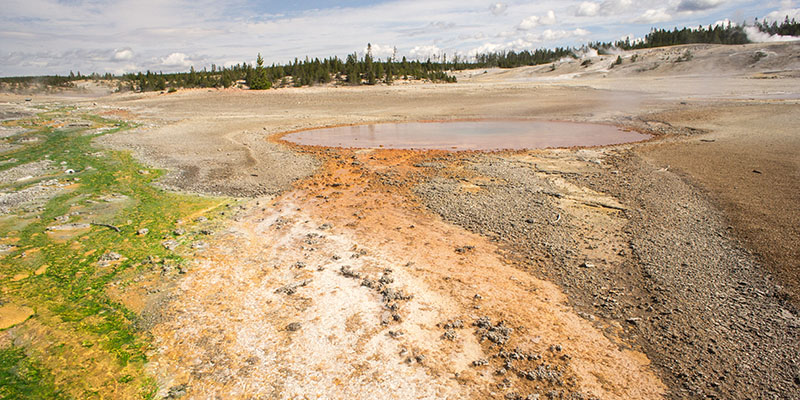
416;150;800;399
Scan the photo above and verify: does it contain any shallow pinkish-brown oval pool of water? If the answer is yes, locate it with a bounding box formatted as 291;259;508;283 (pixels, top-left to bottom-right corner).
283;120;650;150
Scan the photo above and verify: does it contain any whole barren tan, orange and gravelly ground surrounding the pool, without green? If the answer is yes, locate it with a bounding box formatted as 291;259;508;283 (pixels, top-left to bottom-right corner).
5;43;800;399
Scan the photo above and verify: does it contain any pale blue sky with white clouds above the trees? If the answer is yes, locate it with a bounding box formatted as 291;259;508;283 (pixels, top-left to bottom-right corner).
0;0;800;76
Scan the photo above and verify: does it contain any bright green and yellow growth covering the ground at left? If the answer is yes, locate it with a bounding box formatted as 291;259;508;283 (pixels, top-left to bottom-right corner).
0;107;230;398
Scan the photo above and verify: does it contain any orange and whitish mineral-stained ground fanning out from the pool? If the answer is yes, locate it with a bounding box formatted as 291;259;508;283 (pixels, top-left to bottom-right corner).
147;152;665;399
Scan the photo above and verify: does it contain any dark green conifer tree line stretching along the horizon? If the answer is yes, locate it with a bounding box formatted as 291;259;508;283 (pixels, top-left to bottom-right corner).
0;16;800;92
